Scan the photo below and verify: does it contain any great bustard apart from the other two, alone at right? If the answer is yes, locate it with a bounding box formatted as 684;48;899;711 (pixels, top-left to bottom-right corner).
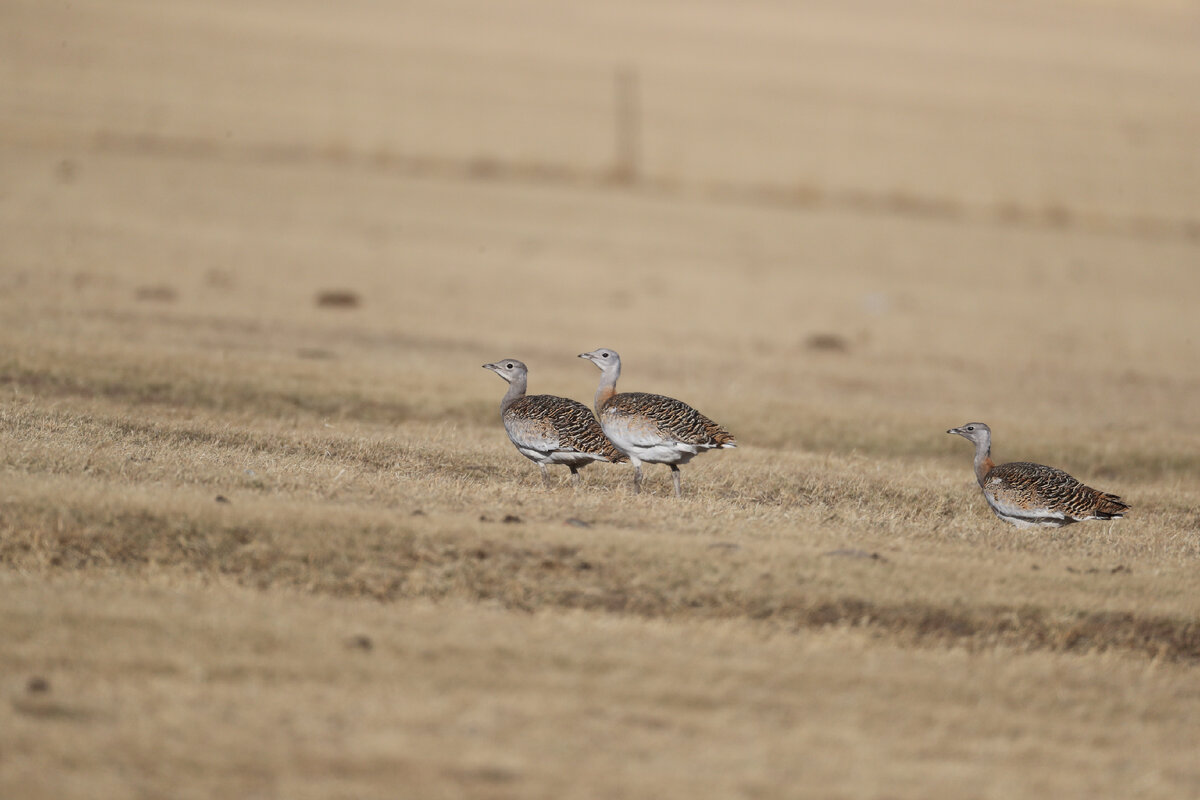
947;422;1129;528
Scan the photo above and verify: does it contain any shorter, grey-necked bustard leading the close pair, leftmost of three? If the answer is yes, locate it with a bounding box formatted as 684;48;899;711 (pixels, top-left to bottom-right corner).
484;359;625;488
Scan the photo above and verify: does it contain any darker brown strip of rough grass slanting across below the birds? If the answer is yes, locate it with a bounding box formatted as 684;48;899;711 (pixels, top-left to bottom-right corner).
0;499;1200;662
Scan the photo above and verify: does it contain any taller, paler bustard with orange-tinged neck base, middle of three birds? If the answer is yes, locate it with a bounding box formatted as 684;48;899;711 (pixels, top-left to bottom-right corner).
580;349;737;498
